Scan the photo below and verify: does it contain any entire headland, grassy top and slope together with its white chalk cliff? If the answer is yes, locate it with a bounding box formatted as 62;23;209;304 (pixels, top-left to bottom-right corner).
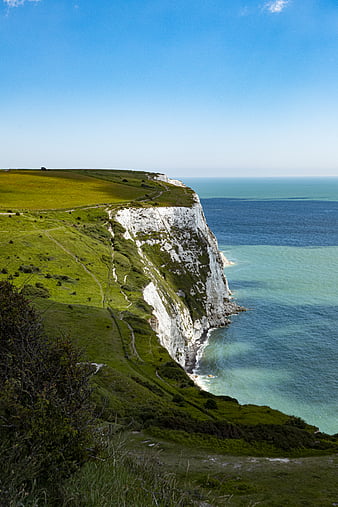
0;169;337;457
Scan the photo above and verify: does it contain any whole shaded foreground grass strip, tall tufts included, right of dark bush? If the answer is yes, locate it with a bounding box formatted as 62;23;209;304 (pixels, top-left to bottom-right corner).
59;432;338;507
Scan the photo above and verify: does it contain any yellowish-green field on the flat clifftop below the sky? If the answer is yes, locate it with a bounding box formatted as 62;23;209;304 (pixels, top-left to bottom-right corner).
0;170;192;211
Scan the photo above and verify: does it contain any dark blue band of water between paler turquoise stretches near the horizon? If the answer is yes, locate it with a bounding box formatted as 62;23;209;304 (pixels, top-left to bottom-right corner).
202;198;338;247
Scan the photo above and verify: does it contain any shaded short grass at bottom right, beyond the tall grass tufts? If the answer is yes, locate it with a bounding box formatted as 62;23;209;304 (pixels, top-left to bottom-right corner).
119;433;338;507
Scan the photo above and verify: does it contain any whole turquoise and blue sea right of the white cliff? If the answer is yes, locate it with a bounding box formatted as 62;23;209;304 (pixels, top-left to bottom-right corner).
183;178;338;434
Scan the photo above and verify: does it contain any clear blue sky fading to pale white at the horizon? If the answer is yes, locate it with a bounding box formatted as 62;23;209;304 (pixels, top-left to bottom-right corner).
0;0;338;177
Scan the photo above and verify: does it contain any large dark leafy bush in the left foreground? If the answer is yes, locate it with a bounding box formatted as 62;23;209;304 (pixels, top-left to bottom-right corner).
0;282;91;505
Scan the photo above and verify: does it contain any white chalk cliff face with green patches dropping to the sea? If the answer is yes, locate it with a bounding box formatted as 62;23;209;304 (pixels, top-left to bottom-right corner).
114;189;238;371
